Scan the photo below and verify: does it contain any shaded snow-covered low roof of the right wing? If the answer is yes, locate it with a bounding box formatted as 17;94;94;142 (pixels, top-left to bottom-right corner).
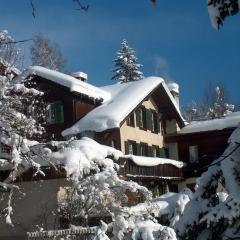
178;112;240;134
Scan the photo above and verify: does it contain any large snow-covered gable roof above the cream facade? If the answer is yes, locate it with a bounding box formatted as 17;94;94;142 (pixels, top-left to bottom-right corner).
62;77;184;136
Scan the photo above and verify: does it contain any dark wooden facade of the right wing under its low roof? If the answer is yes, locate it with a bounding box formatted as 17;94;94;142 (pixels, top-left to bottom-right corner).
165;128;235;178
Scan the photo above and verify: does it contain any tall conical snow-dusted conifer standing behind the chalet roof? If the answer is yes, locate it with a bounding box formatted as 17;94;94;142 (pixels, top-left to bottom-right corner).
112;39;143;83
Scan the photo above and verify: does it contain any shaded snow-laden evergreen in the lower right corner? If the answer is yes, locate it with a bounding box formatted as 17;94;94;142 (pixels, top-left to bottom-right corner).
175;128;240;240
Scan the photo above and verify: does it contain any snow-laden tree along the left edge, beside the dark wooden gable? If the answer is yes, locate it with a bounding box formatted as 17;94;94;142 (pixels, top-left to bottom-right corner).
0;29;45;223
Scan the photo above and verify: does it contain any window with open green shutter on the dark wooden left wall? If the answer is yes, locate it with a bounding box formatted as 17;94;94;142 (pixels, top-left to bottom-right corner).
47;101;64;124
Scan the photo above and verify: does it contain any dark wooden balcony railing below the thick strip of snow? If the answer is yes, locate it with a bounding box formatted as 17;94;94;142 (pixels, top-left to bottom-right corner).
119;158;183;180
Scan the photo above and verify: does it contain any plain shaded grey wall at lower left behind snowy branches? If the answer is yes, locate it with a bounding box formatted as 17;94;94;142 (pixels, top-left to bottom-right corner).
0;179;70;240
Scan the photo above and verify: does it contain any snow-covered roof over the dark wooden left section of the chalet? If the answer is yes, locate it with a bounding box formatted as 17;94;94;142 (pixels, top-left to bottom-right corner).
16;66;109;100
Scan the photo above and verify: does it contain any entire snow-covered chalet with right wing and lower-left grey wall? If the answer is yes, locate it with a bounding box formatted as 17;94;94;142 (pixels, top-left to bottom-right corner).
0;66;240;239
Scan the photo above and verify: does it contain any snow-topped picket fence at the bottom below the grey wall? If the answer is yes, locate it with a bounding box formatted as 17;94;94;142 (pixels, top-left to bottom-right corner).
27;227;98;240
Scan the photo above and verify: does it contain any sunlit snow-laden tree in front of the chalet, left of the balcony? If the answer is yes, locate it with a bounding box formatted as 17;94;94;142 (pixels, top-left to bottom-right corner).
47;138;176;240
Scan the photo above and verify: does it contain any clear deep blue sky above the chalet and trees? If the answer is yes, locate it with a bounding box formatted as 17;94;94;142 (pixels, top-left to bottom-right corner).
0;0;240;105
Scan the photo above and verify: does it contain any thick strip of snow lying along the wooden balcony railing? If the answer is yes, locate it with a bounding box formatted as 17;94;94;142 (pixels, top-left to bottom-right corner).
124;155;184;168
